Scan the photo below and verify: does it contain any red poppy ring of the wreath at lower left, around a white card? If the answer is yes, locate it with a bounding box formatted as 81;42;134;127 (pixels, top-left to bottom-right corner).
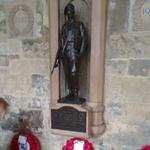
10;129;40;150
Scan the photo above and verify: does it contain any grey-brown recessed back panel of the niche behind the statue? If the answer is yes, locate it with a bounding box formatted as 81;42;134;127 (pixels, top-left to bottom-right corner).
59;0;91;101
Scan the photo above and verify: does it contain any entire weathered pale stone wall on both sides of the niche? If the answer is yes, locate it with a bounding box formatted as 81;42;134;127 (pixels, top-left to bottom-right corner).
0;0;150;150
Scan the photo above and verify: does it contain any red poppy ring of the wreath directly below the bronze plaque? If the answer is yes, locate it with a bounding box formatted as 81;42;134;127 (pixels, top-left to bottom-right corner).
62;137;94;150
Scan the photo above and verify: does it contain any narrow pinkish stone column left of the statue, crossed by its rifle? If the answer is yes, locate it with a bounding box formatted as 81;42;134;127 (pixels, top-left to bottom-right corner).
49;0;59;105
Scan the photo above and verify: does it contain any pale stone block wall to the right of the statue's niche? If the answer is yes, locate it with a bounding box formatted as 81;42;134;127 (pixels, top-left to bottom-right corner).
103;0;150;150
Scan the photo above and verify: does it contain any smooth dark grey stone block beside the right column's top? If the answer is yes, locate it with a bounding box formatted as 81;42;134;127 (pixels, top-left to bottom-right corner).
108;0;130;34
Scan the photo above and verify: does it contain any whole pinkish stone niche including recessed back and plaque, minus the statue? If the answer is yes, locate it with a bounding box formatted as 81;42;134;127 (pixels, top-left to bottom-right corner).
49;0;107;137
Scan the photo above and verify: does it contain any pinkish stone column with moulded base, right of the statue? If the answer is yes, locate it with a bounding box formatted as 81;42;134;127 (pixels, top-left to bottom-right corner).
89;0;107;136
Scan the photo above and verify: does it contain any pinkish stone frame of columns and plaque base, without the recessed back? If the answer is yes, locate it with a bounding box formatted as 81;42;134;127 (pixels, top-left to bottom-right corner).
49;0;107;137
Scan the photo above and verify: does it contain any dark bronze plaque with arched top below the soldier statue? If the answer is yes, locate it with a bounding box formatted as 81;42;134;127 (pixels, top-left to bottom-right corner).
51;106;86;132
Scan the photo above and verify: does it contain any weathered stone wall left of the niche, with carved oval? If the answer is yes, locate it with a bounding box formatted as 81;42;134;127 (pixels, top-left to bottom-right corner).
0;0;50;150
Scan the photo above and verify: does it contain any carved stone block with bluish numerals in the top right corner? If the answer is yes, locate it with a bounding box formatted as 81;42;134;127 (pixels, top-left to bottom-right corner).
132;0;150;31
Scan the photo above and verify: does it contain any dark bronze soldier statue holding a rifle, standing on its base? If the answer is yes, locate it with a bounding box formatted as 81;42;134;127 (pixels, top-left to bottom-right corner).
52;3;87;104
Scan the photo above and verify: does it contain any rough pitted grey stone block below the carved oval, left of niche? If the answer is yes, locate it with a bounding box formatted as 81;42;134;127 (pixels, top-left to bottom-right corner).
23;40;49;58
